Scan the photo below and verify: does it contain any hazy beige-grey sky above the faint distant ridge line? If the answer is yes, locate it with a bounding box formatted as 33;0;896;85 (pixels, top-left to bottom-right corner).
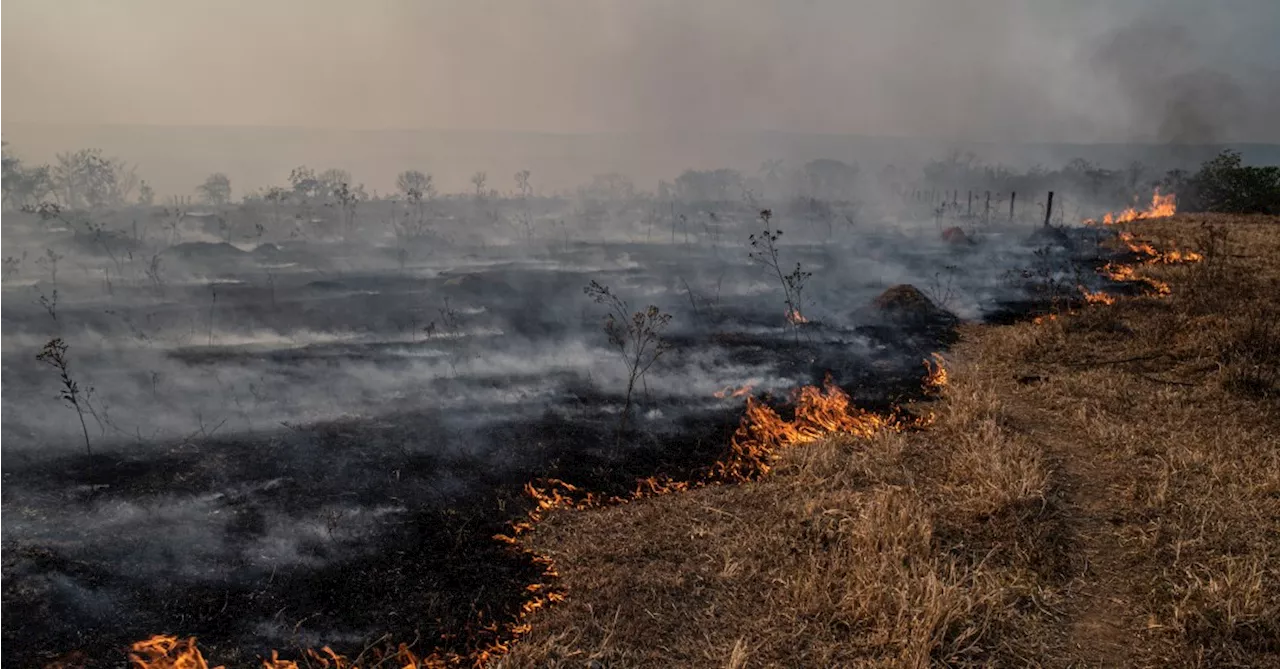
0;0;1280;142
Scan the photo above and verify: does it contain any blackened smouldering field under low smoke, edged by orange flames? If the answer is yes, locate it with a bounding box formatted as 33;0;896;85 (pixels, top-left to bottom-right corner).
0;138;1274;669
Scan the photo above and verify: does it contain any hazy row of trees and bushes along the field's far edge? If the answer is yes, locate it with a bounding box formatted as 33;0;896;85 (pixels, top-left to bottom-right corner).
0;138;1280;214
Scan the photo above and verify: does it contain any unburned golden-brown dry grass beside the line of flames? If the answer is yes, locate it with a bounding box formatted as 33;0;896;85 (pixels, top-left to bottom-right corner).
502;216;1280;668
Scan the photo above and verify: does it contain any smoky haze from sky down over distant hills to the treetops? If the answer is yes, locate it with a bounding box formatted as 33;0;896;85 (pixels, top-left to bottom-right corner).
0;0;1280;196
